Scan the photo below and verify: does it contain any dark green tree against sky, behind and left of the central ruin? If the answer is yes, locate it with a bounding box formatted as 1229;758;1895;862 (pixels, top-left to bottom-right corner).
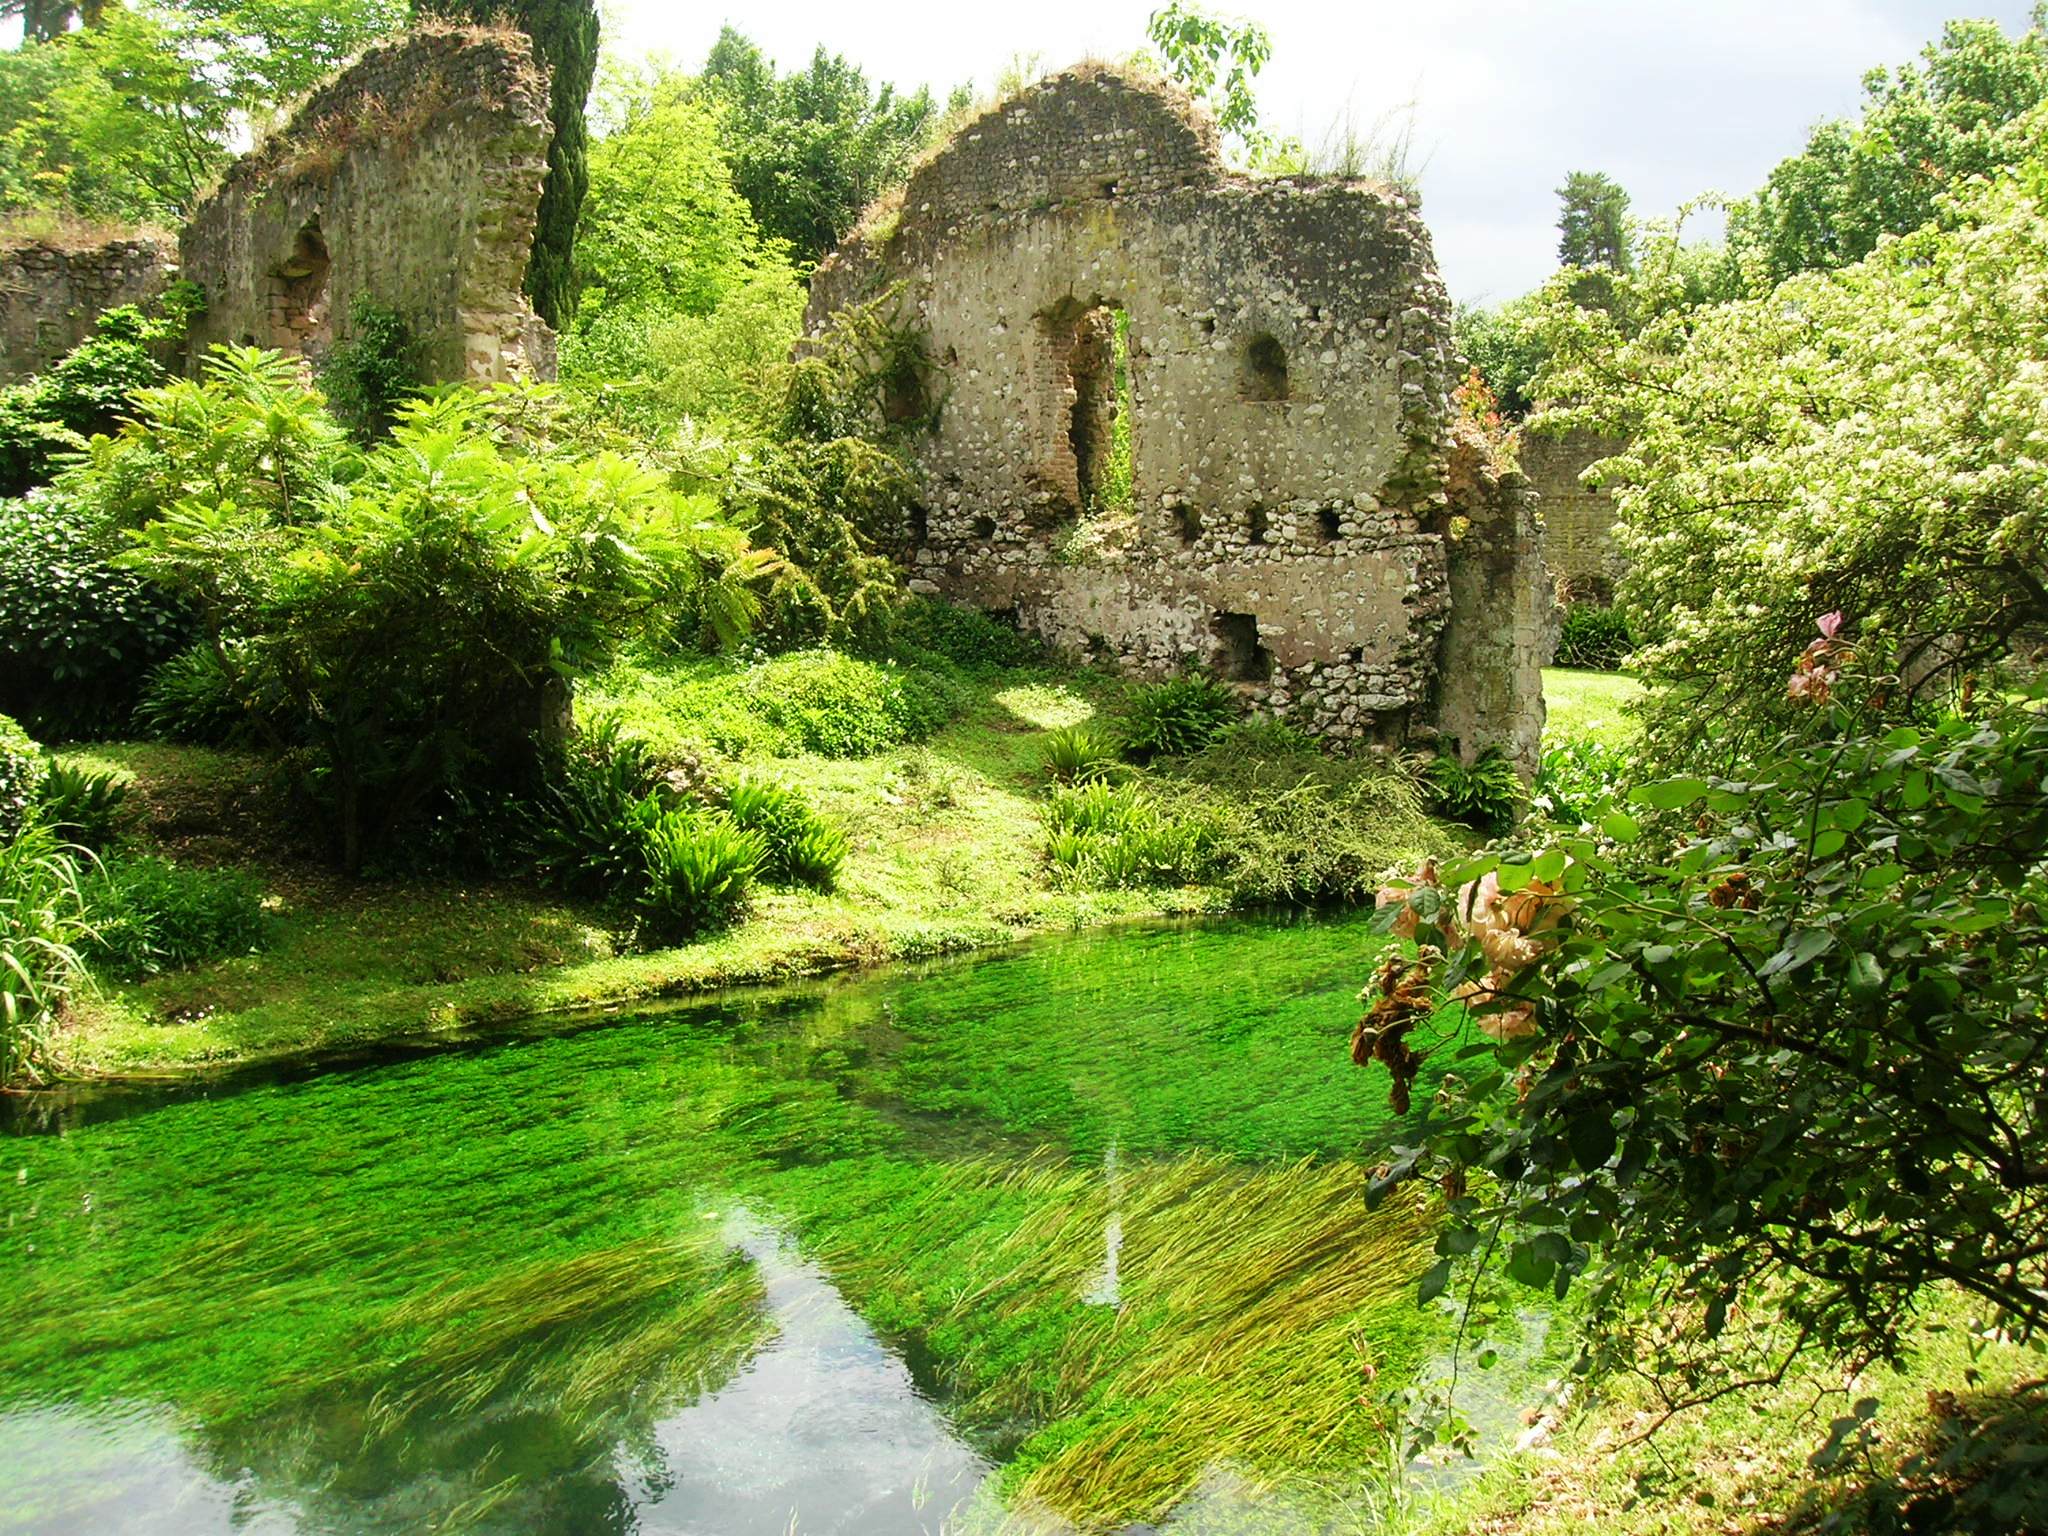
702;27;938;262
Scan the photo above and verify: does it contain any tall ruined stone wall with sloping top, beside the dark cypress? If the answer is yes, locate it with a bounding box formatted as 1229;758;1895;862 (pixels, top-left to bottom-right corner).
180;27;555;381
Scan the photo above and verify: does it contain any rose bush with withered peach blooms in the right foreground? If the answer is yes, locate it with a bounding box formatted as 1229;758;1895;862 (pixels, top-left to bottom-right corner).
1354;655;2048;1458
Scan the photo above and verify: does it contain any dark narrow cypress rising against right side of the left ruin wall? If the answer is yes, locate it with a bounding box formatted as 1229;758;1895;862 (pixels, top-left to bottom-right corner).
414;0;598;330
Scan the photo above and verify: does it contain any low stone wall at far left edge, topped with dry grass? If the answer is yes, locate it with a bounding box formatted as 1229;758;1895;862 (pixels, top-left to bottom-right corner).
0;233;178;383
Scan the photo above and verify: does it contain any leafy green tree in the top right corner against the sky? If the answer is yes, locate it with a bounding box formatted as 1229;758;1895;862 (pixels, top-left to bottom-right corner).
1729;8;2048;285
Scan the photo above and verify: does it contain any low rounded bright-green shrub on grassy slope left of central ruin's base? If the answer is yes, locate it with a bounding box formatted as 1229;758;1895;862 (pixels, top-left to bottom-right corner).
745;651;956;758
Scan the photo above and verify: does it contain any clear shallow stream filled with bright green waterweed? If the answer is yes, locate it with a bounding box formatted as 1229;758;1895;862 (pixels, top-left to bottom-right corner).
0;922;1427;1536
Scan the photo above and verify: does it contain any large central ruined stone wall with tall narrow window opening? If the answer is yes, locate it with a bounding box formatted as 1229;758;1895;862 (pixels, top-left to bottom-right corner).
807;68;1548;768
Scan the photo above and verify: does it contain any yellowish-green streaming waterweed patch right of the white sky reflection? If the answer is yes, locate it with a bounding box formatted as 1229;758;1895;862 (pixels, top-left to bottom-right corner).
790;1153;1430;1530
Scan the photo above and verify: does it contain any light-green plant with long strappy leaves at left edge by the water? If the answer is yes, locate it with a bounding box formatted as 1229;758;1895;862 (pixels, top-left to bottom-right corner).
0;823;88;1083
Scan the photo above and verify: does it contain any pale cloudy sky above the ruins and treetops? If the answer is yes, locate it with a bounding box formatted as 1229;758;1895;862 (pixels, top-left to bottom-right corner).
606;0;2030;301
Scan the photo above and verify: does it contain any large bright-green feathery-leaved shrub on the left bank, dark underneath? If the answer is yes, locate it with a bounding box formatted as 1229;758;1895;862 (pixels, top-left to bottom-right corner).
92;348;752;870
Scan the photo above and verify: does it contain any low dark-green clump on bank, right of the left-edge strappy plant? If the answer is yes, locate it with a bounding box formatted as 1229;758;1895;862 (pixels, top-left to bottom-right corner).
80;856;266;979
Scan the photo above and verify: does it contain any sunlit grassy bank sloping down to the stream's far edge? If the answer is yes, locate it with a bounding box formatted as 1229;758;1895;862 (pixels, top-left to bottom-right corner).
57;670;1466;1075
